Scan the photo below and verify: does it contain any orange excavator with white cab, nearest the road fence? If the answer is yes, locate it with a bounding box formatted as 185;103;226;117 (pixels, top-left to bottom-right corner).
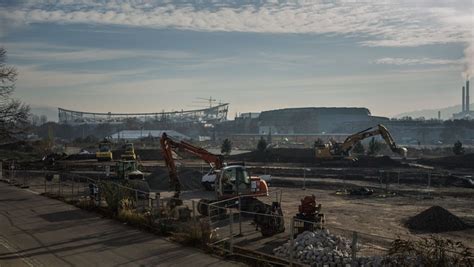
160;133;285;236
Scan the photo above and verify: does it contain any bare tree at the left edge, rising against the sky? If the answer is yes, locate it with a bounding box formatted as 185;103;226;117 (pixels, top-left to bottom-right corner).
0;47;30;141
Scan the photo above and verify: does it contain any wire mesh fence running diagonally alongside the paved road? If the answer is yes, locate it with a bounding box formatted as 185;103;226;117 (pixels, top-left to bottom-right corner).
0;168;472;266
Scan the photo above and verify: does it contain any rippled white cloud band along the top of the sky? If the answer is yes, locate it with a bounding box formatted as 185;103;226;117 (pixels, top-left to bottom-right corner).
0;0;474;47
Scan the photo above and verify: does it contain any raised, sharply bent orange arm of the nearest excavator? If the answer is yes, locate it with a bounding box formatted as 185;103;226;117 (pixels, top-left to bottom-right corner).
160;133;223;198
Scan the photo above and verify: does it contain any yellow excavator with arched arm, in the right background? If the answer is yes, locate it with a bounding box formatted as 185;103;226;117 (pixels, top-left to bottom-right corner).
315;124;407;160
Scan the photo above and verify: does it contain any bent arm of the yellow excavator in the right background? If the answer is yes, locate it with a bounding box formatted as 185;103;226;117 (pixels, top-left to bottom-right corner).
341;124;407;158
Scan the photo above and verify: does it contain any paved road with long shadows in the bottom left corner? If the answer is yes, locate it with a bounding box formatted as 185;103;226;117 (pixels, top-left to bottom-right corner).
0;182;240;267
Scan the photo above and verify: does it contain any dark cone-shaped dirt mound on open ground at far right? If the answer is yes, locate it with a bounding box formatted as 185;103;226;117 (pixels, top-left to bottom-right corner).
405;206;468;233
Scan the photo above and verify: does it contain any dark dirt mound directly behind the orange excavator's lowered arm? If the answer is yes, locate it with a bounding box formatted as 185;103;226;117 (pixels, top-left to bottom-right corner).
147;168;203;190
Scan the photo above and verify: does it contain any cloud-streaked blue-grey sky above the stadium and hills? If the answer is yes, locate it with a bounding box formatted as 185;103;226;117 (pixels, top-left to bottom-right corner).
0;0;474;118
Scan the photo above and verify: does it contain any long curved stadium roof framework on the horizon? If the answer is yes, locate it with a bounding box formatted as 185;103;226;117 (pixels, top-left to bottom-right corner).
58;103;229;125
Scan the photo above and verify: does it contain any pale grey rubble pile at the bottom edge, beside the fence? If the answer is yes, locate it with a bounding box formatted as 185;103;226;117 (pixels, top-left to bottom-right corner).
273;229;358;266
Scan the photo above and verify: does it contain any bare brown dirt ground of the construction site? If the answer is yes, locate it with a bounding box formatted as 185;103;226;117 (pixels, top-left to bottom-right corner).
5;160;474;262
